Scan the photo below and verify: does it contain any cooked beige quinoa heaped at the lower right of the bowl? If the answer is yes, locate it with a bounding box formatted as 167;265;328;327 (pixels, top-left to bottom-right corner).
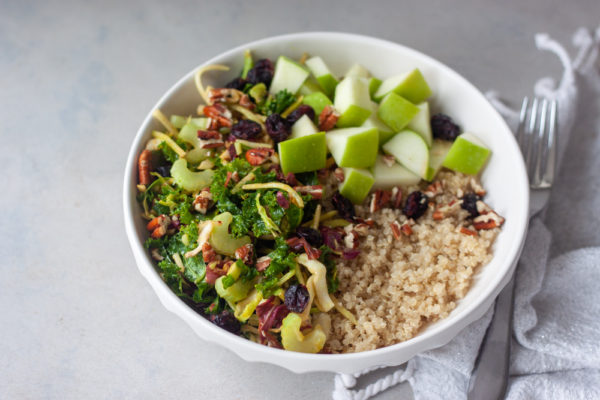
327;171;500;353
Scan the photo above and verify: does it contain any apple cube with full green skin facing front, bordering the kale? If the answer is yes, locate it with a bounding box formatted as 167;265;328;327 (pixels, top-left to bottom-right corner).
278;132;327;174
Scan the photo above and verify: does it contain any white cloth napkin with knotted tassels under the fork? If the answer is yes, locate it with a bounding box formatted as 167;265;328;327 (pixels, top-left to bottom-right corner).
333;28;600;400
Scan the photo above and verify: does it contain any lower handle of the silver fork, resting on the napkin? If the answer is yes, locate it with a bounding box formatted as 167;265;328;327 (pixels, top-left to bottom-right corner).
467;274;515;400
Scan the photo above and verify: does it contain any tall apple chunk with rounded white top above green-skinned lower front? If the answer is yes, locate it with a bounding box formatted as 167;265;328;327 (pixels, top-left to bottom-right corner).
333;77;371;128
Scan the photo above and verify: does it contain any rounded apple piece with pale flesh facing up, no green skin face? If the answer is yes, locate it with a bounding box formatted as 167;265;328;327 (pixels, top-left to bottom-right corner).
383;130;429;178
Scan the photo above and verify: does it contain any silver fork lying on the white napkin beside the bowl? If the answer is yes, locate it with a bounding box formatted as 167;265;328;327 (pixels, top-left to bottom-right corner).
468;97;558;400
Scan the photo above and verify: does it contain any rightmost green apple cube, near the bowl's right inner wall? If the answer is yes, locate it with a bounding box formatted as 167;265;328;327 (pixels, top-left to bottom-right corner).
442;132;490;175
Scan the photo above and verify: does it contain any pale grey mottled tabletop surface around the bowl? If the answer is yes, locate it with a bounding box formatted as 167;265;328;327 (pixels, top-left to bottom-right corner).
0;0;600;399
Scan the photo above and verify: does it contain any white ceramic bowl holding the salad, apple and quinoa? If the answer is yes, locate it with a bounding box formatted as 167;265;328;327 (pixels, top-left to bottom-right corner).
123;32;529;373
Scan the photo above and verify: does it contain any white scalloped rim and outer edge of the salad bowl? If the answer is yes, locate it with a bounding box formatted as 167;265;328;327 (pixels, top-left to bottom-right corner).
123;32;529;373
